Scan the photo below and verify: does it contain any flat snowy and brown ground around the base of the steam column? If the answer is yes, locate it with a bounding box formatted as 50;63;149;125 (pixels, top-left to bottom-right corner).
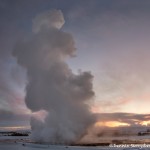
0;128;150;150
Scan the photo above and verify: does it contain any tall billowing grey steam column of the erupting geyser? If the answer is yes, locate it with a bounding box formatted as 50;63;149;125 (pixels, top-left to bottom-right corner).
13;10;95;143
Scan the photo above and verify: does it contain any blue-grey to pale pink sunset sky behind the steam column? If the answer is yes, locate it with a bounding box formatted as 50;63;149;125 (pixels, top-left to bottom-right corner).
0;0;150;127
